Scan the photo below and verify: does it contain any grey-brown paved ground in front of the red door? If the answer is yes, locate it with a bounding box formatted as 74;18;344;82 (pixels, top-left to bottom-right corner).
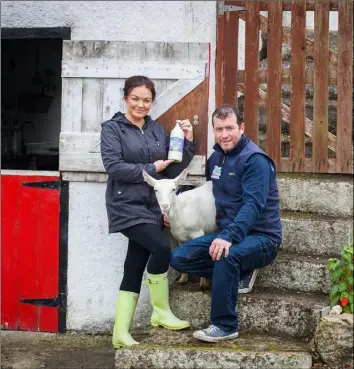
1;331;114;369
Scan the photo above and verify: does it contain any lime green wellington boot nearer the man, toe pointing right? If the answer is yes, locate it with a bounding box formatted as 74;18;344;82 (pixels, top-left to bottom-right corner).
144;272;190;330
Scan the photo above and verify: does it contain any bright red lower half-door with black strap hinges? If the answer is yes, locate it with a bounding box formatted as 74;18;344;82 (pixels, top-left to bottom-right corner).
1;175;60;332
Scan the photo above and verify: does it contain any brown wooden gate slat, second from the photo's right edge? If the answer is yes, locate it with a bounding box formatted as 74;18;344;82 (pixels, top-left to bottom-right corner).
312;2;329;172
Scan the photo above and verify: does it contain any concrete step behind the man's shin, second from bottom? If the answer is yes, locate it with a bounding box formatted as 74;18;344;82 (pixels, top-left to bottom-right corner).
170;282;329;337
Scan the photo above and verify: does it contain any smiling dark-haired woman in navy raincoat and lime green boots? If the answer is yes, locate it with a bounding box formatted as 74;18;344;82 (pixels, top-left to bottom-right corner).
101;76;195;348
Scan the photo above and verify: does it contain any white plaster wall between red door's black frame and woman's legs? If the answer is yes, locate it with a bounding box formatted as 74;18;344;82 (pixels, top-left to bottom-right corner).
67;182;127;330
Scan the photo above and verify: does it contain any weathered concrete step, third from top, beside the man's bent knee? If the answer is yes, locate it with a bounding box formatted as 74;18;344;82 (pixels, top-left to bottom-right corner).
255;251;331;294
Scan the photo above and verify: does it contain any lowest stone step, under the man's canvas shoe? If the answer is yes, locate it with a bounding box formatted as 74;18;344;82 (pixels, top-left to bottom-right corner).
116;328;312;368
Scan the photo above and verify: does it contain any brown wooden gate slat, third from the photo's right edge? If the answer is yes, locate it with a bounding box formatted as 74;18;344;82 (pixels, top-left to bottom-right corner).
290;2;306;172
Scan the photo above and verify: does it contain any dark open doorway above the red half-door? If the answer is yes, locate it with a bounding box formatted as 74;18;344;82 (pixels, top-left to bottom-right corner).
1;29;67;171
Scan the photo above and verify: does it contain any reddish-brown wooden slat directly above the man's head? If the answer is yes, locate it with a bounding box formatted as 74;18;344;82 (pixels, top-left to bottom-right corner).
223;6;239;105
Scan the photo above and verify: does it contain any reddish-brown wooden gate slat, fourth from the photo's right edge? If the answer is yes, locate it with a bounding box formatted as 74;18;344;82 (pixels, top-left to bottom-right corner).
267;2;283;168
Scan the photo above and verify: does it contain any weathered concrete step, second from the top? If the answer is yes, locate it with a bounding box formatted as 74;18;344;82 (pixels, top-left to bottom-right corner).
282;211;353;257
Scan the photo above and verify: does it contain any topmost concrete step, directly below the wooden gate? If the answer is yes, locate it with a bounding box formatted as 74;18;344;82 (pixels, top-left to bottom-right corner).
277;173;353;217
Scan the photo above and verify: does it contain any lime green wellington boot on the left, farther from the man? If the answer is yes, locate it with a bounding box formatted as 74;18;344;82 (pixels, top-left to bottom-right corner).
112;291;139;348
